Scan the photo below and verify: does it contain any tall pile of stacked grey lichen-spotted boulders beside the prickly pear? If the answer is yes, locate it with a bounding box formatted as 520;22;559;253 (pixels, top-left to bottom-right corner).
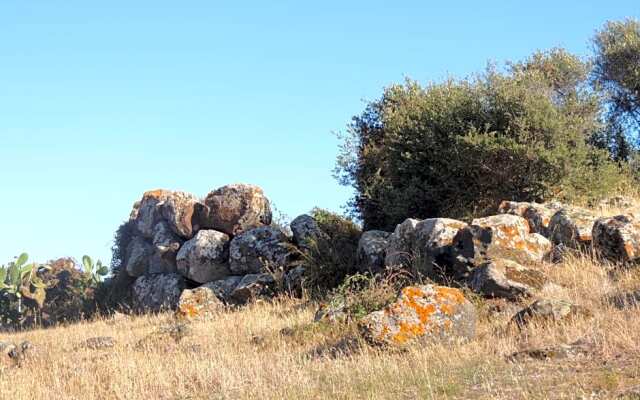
122;184;308;316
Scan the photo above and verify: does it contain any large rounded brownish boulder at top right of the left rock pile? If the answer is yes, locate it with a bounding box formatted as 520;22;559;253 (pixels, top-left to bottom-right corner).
203;184;271;236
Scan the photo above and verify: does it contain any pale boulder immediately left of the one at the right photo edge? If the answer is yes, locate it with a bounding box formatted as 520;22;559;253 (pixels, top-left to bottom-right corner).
549;207;597;249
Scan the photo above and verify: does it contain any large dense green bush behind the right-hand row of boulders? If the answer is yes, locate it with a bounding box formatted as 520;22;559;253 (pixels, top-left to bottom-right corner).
336;49;626;231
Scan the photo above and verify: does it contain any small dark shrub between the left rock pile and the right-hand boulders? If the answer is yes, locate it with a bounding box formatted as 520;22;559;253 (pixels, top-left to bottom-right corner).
304;208;362;294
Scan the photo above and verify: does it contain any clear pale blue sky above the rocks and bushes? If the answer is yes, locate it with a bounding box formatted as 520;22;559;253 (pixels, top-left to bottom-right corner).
0;0;640;263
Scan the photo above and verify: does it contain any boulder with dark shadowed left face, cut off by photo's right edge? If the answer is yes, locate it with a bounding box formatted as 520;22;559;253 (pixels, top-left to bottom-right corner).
592;215;640;263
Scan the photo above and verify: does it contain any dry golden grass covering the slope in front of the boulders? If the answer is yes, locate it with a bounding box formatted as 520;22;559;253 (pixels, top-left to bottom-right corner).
0;257;640;400
